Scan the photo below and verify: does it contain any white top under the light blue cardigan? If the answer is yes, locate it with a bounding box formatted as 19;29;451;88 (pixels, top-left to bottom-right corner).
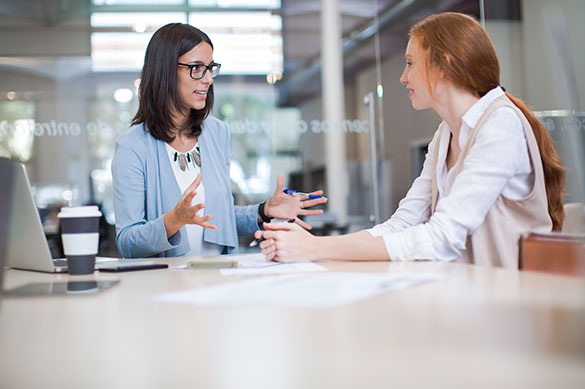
166;143;223;256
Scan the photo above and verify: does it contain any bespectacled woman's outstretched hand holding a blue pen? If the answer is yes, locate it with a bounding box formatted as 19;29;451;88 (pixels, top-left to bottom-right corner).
264;174;327;230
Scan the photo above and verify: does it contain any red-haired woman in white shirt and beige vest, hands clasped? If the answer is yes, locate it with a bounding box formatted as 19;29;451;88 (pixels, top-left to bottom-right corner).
256;13;565;269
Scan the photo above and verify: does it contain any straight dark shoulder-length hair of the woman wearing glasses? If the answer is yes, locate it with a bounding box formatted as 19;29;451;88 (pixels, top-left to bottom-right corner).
132;23;213;142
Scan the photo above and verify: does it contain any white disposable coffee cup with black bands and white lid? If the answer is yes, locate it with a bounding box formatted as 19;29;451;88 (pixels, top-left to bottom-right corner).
57;205;102;274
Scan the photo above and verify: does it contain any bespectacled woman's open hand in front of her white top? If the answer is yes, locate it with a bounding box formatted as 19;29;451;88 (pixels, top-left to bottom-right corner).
164;174;217;238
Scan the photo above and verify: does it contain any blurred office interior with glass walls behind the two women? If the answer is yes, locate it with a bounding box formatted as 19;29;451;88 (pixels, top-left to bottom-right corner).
0;0;585;255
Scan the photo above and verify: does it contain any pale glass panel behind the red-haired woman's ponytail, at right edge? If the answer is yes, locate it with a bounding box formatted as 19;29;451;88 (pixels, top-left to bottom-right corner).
485;0;585;203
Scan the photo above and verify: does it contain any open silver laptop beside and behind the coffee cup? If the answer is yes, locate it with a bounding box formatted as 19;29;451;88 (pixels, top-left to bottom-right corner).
2;159;114;273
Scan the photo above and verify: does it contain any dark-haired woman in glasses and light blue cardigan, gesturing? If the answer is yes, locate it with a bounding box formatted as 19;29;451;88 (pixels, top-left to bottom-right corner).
112;23;326;258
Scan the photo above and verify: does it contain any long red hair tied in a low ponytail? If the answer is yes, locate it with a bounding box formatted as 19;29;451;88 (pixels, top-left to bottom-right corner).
410;12;566;231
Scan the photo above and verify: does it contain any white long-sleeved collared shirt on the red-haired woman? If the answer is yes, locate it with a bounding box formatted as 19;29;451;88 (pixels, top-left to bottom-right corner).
367;87;534;261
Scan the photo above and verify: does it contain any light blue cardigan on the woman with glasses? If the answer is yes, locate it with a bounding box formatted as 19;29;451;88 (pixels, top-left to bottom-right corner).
112;116;260;258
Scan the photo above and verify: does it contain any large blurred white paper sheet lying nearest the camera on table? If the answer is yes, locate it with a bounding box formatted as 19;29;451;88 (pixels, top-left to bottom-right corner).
154;273;439;308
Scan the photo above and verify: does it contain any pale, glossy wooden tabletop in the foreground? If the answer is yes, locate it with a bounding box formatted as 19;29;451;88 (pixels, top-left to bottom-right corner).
0;259;585;389
